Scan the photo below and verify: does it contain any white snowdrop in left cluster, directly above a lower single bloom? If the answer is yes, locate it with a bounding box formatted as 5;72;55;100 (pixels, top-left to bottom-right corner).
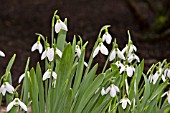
41;47;54;61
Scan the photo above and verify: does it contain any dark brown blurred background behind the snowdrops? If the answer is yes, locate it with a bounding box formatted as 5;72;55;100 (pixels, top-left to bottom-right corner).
0;0;170;85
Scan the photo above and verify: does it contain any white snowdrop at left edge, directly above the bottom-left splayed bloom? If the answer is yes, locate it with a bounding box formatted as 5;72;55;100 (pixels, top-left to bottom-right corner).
0;82;14;96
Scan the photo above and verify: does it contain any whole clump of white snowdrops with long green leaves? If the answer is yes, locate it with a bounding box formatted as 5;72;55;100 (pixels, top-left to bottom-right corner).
0;11;170;113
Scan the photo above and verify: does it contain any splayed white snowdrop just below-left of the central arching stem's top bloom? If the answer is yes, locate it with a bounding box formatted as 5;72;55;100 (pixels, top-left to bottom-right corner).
93;42;109;58
